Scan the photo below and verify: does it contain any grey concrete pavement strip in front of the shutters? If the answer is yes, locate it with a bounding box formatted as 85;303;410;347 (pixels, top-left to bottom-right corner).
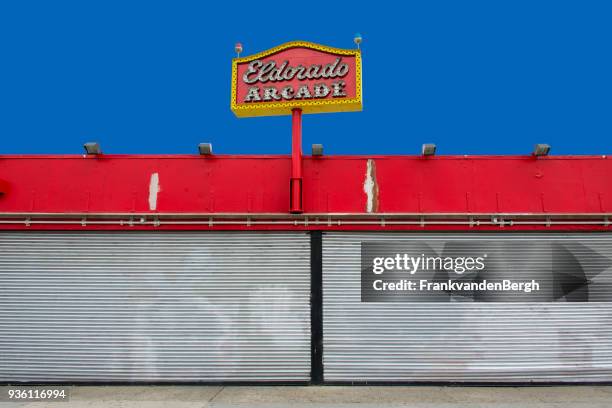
0;386;612;408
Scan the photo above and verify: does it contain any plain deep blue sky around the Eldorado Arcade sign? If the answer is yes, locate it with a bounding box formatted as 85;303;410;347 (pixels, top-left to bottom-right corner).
0;1;612;154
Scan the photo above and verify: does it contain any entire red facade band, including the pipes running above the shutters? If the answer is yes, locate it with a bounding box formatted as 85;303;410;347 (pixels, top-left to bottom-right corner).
0;155;612;230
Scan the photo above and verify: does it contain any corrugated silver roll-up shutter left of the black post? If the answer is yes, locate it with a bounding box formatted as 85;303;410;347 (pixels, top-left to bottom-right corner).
0;232;310;382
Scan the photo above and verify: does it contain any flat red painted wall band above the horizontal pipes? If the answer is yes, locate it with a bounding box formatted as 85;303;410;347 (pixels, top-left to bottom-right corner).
0;155;612;213
